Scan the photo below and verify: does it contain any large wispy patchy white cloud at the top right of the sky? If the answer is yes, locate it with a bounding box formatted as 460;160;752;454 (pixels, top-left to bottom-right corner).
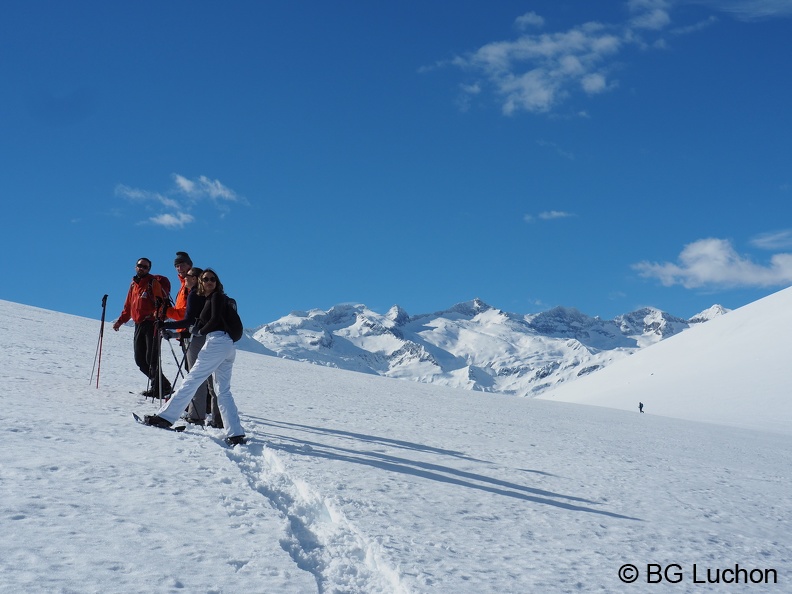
446;0;792;116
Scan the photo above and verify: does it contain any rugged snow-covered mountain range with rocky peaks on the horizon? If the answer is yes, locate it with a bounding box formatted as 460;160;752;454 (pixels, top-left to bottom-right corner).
250;299;728;396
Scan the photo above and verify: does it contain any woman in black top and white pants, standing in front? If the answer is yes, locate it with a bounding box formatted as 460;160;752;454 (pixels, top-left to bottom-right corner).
143;268;245;446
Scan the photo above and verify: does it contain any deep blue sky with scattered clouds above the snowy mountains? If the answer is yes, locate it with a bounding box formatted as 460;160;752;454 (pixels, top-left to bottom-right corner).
0;0;792;327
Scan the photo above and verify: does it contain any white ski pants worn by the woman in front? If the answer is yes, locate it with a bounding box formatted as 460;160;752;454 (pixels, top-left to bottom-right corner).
157;331;245;437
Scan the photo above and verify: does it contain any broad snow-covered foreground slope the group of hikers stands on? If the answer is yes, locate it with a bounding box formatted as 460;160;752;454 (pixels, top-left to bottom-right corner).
0;300;792;594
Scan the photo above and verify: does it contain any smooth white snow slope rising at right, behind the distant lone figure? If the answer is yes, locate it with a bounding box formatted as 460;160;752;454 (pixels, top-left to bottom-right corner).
540;288;792;434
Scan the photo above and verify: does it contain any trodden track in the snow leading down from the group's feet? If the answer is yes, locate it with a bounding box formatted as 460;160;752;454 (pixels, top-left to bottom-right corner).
228;440;408;594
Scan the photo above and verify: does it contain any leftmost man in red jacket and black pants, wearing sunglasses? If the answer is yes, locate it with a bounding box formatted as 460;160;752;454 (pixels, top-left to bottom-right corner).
113;258;172;397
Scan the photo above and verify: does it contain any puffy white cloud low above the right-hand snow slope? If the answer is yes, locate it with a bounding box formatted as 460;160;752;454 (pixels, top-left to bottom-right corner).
633;238;792;289
